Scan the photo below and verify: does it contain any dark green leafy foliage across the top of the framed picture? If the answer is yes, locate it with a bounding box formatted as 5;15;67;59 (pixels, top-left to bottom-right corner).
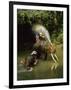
17;9;63;43
